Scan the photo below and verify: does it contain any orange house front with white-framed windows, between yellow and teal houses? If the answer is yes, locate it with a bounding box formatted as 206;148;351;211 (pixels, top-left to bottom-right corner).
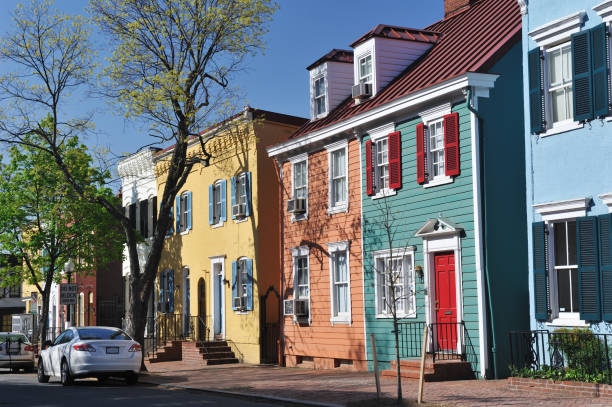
268;130;367;370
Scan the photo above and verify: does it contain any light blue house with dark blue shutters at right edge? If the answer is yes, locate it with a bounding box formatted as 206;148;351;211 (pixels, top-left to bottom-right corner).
519;0;612;344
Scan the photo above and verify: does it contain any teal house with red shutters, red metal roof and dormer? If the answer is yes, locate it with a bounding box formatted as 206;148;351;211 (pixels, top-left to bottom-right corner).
290;0;529;379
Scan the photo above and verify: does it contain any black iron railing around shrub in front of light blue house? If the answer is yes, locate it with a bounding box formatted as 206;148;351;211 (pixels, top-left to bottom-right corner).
509;329;612;384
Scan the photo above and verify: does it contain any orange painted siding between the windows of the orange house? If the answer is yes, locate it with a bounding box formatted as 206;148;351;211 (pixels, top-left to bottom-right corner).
282;140;367;370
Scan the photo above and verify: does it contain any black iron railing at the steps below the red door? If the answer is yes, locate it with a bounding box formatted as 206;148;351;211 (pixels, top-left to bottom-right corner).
398;322;478;371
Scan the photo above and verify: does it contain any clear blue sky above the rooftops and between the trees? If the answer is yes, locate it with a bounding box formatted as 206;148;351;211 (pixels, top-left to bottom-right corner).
0;0;443;158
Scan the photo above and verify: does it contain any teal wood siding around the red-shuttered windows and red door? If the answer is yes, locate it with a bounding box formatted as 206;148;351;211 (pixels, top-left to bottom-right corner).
361;103;480;371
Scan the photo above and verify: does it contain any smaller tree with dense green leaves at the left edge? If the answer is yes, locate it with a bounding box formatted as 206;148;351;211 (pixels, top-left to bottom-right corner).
0;120;123;343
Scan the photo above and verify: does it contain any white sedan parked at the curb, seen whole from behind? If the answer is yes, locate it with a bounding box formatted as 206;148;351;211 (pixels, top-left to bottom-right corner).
38;326;142;386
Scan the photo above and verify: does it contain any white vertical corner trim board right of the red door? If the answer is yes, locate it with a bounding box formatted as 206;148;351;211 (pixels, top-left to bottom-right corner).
468;109;489;378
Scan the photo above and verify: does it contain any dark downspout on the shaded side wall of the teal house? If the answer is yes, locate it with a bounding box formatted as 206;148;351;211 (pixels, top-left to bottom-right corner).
466;87;499;379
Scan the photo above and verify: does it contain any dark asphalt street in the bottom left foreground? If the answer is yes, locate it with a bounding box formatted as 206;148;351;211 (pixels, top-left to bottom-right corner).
0;369;279;407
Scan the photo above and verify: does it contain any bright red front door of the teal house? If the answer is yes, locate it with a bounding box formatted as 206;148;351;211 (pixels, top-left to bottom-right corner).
434;252;457;350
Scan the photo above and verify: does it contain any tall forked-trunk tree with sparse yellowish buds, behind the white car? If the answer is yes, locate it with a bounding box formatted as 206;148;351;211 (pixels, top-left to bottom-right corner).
0;0;276;350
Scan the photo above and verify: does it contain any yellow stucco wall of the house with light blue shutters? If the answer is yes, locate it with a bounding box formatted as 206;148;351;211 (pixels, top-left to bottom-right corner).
155;113;297;363
